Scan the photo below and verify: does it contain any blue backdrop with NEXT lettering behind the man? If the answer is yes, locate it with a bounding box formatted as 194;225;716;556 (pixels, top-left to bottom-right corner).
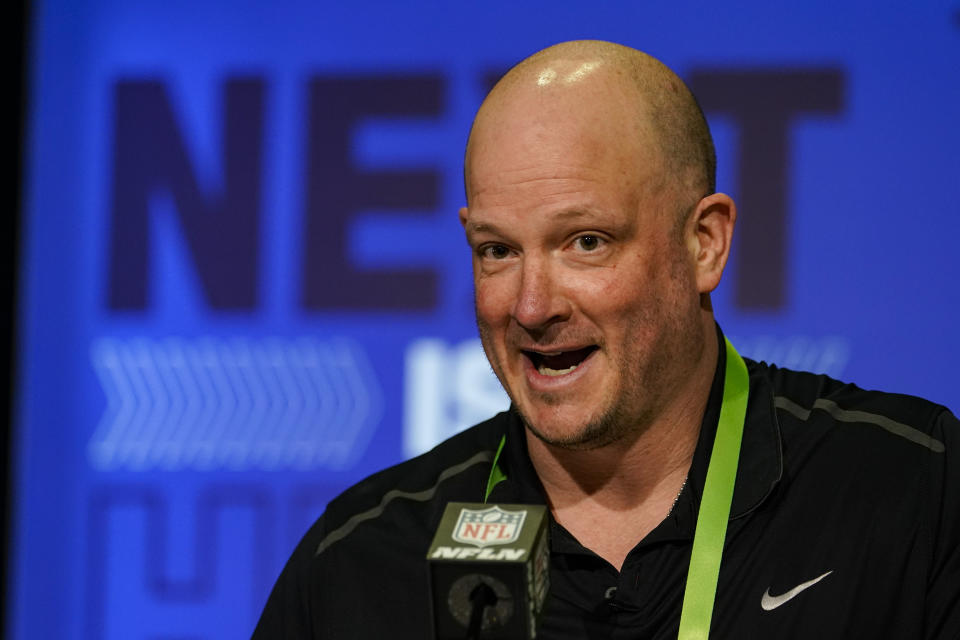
13;0;960;640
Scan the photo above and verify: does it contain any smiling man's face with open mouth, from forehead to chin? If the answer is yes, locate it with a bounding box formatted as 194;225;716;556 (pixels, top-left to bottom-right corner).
461;81;703;448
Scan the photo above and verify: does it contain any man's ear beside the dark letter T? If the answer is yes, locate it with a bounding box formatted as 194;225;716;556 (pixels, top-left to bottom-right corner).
686;193;737;293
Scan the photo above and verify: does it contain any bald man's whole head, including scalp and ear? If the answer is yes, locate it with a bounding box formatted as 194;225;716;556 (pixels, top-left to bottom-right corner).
460;41;736;448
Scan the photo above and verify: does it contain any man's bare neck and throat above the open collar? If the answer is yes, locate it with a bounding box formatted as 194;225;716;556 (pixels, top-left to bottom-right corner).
527;322;718;569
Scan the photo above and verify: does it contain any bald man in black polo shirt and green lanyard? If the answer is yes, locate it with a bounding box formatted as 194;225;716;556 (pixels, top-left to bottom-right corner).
254;41;960;640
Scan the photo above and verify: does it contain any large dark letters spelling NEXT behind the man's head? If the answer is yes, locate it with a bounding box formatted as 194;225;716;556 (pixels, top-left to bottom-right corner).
106;69;845;312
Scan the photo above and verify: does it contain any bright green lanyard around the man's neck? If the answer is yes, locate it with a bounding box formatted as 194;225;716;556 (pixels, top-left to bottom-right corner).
483;339;750;640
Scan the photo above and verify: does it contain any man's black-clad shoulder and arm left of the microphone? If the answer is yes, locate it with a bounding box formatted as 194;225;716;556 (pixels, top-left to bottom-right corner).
254;414;512;638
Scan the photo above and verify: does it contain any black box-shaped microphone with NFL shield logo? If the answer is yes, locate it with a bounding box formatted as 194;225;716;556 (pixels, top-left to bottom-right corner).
427;502;550;640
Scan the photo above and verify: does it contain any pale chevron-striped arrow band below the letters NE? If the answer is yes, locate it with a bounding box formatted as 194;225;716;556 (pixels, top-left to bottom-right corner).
87;337;383;471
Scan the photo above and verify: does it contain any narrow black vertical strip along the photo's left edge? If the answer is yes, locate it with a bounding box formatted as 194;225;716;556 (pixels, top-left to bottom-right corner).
0;0;31;634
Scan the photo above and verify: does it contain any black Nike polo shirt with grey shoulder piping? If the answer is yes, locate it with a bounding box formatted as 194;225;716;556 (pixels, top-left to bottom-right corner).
254;350;960;640
